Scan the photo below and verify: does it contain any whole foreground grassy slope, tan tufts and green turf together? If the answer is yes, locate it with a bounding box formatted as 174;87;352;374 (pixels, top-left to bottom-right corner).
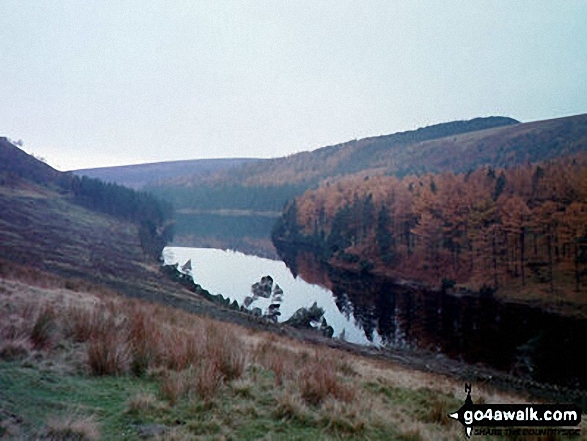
0;275;568;440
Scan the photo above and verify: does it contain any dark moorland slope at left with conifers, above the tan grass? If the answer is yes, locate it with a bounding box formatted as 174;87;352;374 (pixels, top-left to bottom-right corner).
0;138;171;276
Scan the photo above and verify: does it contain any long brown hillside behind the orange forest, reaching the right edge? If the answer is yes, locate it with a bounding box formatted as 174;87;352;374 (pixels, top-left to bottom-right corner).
150;115;587;210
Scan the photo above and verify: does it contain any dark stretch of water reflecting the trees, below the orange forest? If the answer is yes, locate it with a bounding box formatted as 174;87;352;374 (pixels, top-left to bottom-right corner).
279;250;587;389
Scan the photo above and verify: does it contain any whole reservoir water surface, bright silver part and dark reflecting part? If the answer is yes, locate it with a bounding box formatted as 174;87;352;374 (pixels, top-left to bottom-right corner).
164;247;587;390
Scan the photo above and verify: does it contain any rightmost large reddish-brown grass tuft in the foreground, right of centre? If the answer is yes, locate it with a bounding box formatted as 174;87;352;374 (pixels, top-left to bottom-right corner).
297;358;356;406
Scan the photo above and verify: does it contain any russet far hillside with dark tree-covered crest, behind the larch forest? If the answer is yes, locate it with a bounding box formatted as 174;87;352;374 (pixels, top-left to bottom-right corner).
160;117;519;187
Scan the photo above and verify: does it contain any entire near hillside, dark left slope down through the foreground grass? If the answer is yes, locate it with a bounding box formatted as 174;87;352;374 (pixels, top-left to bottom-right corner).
0;137;560;440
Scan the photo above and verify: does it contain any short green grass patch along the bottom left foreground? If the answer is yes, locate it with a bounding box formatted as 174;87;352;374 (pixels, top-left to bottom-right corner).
0;361;398;440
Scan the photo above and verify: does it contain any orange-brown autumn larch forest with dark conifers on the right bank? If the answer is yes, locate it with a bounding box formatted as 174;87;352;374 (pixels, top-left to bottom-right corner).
273;157;587;294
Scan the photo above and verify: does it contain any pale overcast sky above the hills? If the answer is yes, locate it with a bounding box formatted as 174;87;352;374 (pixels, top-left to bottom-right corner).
0;0;587;170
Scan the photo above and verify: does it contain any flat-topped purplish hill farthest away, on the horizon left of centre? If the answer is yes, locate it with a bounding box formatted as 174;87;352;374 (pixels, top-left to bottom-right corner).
73;158;262;189
